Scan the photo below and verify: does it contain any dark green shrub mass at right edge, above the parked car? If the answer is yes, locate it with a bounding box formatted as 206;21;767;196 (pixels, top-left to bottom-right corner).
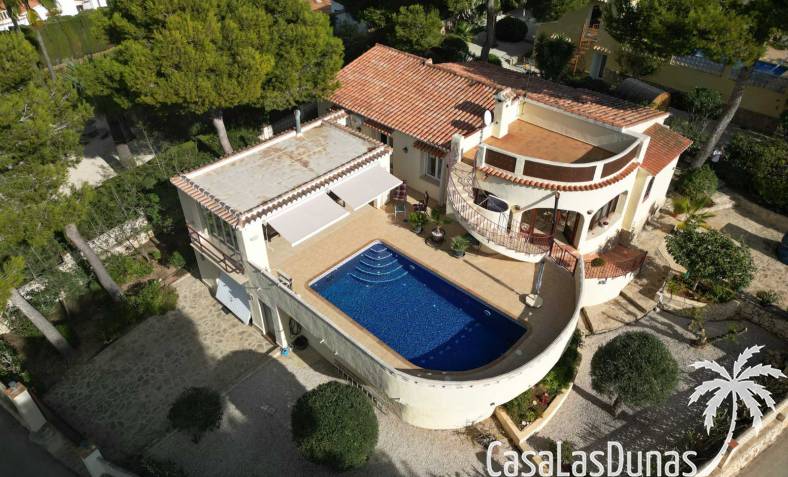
715;133;788;213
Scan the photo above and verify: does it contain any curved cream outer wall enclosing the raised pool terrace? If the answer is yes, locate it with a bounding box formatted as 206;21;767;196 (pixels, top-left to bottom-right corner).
246;260;583;429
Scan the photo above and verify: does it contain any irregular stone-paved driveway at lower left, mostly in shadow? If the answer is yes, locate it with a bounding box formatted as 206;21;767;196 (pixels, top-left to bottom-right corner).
44;275;274;459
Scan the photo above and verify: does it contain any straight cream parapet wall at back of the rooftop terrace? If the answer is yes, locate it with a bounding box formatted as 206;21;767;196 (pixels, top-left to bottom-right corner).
522;100;636;152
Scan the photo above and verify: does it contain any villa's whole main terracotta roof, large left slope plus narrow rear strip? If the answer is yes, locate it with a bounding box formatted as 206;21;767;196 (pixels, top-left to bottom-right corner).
331;45;667;148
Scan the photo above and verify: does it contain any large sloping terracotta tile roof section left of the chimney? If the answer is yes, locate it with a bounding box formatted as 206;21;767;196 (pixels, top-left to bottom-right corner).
331;45;497;147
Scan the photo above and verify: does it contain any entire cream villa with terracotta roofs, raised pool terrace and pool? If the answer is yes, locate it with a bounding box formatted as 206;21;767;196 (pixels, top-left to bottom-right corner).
172;45;689;429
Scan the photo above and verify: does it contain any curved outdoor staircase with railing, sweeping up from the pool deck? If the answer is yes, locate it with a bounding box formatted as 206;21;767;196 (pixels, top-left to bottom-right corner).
447;168;552;261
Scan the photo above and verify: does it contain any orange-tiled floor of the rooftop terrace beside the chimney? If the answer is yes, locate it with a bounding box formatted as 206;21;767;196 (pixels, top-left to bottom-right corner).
464;119;616;164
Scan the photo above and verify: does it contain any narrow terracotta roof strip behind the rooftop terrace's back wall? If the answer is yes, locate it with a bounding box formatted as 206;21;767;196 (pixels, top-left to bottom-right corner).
436;61;667;127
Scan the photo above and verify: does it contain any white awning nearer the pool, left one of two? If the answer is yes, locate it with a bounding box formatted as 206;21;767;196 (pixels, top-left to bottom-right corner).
268;194;350;247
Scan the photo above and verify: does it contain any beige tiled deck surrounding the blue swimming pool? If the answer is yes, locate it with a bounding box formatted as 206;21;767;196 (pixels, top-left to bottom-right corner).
268;201;575;379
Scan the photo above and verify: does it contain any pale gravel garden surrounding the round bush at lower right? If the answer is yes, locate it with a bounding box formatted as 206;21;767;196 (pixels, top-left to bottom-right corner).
528;312;787;451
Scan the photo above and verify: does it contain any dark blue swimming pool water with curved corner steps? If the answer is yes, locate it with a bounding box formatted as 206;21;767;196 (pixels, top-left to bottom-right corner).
310;242;525;371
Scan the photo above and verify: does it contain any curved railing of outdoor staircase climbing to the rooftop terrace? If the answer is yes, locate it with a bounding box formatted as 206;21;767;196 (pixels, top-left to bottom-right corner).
447;172;552;254
